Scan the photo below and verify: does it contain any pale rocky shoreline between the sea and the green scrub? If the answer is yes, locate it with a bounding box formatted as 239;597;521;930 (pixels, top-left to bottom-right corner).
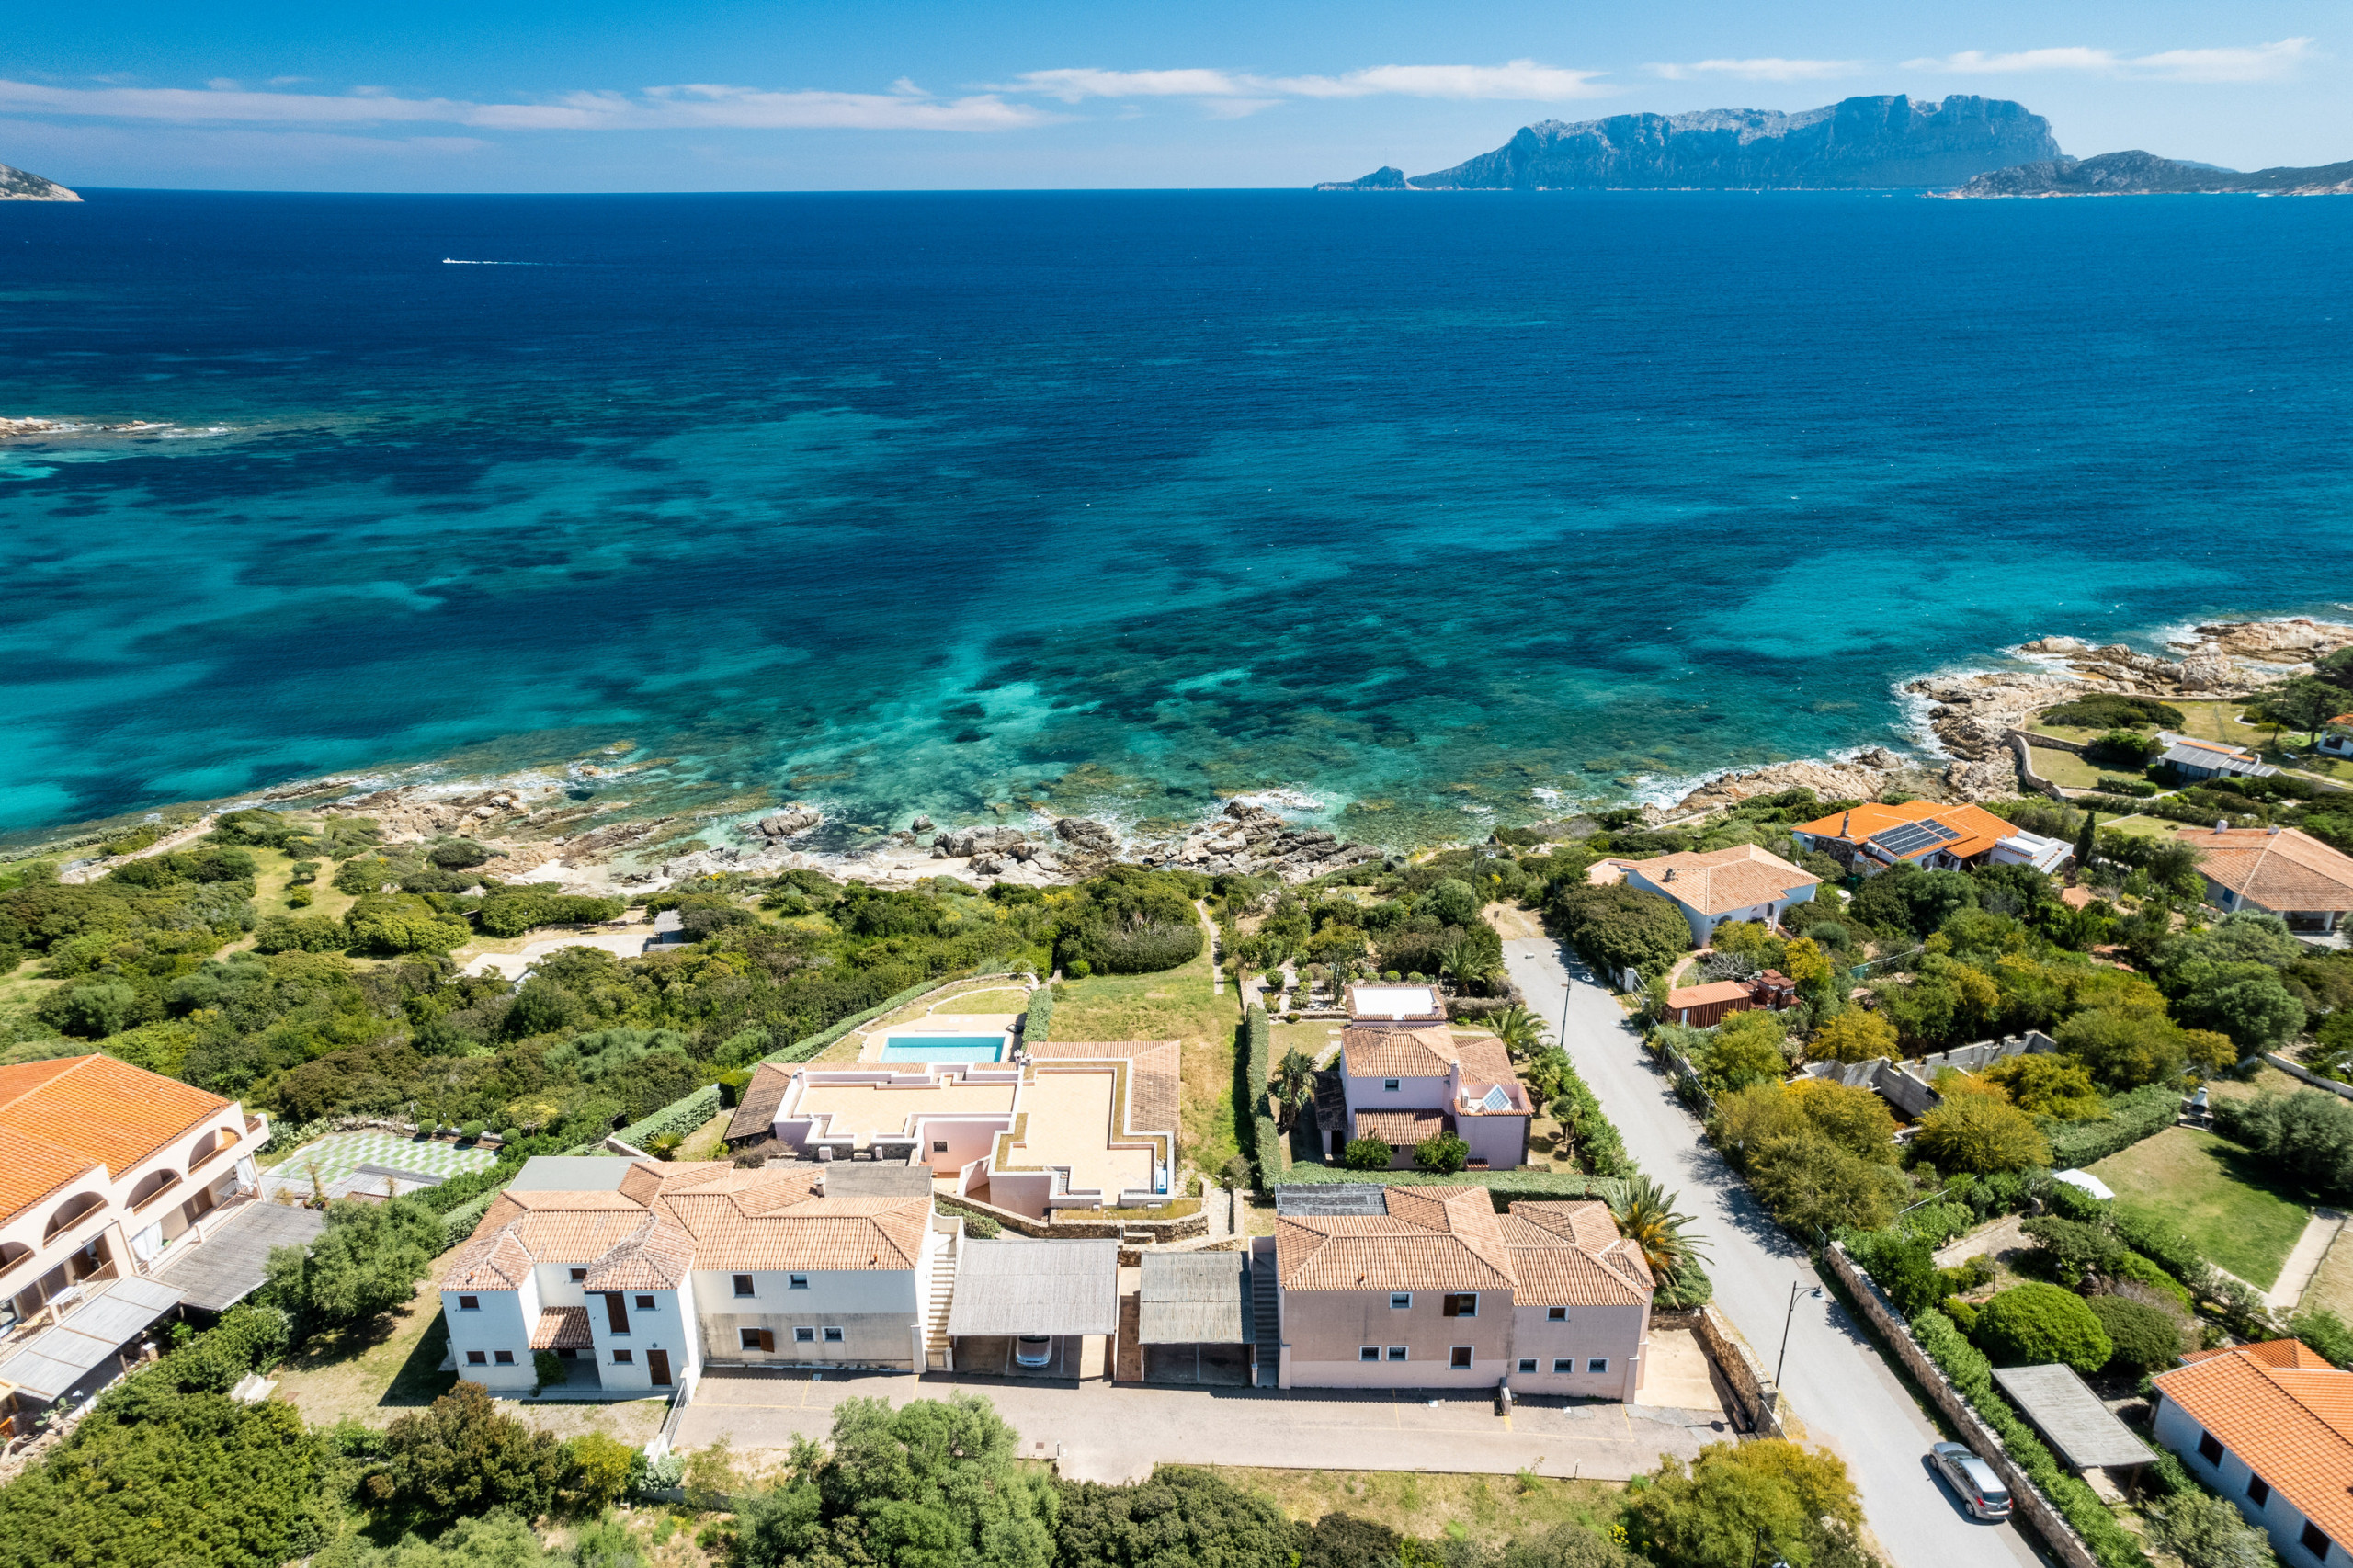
28;617;2353;892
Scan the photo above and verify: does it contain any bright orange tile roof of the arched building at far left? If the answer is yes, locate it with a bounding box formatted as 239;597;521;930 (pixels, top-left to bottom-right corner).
0;1055;243;1221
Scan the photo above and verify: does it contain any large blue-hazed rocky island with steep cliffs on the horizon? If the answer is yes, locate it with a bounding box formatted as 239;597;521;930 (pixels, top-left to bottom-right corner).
1315;94;2062;190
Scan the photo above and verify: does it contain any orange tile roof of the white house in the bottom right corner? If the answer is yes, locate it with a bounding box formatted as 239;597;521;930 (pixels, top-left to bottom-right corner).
2155;1340;2353;1542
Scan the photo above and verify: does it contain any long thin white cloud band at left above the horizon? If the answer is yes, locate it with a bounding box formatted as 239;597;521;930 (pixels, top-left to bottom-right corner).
0;80;1056;131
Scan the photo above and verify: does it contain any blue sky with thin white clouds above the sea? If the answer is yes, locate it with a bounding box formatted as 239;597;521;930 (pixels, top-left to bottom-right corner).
0;0;2353;190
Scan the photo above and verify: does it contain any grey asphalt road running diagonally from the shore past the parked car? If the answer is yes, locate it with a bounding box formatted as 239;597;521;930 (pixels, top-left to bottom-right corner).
1504;939;2047;1568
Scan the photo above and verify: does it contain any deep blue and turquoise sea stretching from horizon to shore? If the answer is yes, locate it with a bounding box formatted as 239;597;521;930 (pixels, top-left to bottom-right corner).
0;190;2353;843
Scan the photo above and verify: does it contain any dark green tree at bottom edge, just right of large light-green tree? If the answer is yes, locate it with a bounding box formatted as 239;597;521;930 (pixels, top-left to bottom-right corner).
1054;1464;1302;1568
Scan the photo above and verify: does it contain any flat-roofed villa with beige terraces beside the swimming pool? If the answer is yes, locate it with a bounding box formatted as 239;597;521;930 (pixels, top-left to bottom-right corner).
727;1031;1179;1220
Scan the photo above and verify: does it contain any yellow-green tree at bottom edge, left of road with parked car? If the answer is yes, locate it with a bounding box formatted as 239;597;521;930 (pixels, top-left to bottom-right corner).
1626;1438;1864;1568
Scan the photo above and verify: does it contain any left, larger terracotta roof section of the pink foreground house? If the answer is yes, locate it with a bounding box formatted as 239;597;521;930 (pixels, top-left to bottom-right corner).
1276;1187;1513;1290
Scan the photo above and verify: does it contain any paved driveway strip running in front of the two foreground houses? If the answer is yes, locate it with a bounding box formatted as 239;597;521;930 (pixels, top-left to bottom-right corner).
676;1370;1730;1481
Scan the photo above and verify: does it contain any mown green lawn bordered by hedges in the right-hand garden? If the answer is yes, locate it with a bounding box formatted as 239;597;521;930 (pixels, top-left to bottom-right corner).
2089;1128;2311;1290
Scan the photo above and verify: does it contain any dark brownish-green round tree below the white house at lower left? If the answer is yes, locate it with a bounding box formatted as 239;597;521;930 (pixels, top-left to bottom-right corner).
383;1382;564;1523
